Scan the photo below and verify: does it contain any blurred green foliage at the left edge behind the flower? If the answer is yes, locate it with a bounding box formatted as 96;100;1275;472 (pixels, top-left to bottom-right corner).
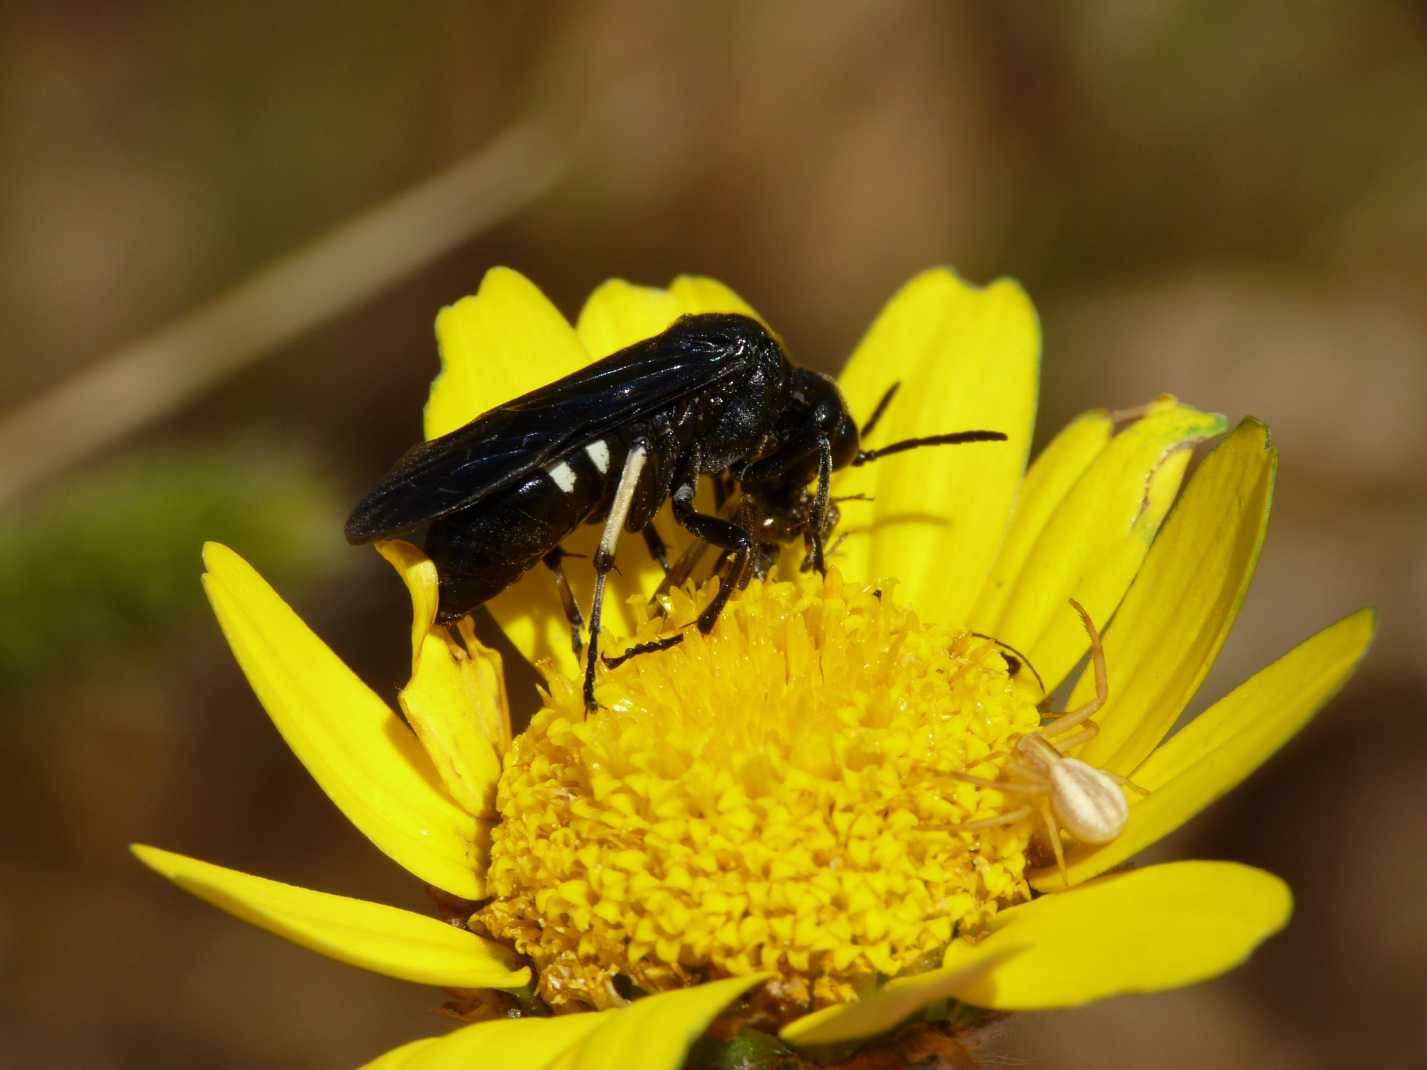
0;444;342;685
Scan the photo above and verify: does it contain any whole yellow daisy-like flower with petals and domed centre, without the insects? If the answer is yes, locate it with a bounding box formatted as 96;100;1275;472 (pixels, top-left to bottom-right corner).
134;270;1374;1070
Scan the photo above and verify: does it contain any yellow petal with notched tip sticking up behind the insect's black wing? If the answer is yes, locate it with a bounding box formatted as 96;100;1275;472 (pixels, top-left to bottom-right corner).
425;267;589;438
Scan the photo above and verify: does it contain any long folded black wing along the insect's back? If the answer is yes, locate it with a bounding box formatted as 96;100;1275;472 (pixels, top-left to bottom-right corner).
347;315;772;544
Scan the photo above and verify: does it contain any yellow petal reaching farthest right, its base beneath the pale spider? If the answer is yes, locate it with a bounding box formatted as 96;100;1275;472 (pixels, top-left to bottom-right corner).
1030;609;1377;892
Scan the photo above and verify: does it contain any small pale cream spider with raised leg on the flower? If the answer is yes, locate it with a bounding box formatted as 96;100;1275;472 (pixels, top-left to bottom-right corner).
950;598;1149;885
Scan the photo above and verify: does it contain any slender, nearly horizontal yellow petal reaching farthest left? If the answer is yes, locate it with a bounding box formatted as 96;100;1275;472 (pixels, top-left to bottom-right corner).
133;845;529;989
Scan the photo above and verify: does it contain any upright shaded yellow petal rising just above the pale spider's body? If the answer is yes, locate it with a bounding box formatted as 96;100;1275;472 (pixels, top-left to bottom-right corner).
1069;419;1279;773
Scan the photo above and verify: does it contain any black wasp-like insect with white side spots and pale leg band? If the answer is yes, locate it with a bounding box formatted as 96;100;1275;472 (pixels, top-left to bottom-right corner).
347;312;1005;709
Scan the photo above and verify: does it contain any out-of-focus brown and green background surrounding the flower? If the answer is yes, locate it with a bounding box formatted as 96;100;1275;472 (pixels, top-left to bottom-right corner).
0;0;1427;1070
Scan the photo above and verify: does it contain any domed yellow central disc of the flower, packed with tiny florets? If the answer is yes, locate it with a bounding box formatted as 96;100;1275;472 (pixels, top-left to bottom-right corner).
472;572;1040;1017
